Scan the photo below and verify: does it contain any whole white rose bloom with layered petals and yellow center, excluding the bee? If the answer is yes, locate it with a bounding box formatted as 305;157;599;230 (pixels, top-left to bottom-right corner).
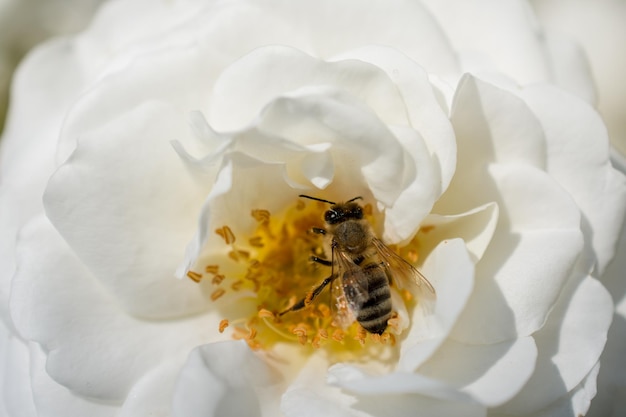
0;0;626;416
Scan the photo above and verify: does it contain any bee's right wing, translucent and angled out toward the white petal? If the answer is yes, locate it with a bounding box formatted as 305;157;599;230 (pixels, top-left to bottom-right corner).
372;238;437;309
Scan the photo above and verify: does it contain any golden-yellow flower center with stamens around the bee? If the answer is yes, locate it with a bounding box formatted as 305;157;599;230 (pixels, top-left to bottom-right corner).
188;200;416;354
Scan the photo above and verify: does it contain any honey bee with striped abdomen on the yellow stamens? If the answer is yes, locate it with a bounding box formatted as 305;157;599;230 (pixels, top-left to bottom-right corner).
280;195;435;334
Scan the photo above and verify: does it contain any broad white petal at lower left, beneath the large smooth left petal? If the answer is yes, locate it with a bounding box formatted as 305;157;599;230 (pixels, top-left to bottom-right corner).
10;214;219;402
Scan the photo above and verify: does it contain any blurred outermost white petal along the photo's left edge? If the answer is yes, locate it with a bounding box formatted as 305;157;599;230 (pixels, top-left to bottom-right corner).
0;40;87;318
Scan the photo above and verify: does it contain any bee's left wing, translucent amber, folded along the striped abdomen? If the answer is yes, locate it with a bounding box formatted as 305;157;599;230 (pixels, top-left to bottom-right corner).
330;250;367;328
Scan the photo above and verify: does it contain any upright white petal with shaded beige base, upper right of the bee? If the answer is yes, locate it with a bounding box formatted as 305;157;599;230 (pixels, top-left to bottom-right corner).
434;76;546;214
